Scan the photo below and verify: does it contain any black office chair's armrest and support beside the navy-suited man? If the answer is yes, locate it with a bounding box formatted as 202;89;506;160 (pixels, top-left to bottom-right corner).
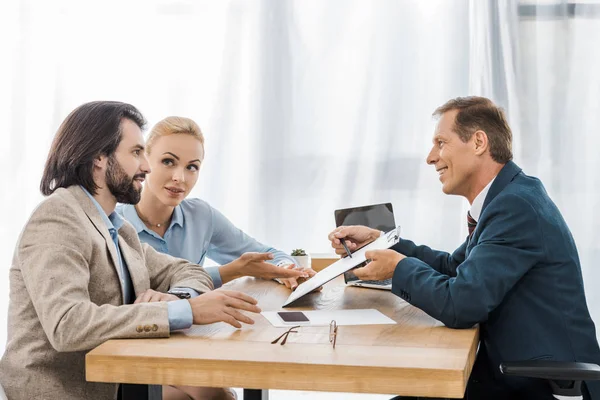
500;360;600;400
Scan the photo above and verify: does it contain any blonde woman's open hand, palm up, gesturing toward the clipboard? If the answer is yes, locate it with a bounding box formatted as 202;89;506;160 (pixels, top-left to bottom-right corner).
219;253;309;283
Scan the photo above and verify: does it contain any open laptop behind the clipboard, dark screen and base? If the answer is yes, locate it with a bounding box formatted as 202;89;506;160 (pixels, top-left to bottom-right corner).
334;203;396;290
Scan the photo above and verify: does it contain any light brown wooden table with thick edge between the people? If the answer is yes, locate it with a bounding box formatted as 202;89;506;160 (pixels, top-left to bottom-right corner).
86;277;478;398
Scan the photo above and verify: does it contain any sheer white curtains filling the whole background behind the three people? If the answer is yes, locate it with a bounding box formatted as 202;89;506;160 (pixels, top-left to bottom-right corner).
0;0;600;353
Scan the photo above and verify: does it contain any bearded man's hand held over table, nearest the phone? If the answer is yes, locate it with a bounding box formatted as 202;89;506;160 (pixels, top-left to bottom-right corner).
188;289;260;328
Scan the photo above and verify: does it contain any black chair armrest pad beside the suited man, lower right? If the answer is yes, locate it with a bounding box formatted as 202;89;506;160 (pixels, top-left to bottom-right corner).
500;360;600;381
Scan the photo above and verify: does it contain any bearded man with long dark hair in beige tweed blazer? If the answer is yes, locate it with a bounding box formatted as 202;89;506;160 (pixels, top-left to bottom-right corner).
0;101;302;400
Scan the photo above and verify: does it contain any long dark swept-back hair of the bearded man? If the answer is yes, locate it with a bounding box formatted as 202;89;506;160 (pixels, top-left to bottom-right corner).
40;101;146;196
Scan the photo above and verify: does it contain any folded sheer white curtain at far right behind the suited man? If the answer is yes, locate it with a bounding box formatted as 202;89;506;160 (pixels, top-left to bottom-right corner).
469;0;600;328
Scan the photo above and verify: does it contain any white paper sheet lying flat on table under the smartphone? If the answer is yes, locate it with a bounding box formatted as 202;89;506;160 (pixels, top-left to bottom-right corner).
261;309;396;328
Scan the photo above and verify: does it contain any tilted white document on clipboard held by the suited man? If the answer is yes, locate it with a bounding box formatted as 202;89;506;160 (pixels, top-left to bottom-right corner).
282;228;399;307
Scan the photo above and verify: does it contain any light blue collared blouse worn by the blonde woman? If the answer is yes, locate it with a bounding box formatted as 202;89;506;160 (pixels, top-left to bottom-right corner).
117;199;295;288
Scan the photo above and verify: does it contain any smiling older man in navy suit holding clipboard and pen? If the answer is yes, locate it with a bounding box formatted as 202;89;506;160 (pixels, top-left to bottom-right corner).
329;97;600;399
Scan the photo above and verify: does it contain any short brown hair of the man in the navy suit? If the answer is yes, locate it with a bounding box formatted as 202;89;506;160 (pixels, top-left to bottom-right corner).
433;96;513;164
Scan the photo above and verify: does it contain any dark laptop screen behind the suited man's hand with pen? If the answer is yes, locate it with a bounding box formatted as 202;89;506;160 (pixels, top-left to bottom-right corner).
335;203;396;232
